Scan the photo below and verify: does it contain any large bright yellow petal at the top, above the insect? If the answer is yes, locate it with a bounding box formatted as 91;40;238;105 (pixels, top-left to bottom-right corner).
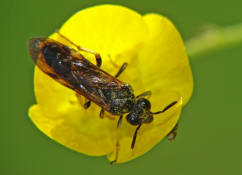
51;5;148;74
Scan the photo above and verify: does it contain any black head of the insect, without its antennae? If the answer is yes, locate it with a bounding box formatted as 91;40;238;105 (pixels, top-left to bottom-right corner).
126;98;153;125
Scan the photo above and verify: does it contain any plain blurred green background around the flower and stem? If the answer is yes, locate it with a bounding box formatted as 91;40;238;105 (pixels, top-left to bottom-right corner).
0;0;242;175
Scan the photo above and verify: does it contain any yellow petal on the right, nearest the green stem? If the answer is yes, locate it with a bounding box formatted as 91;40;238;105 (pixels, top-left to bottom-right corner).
139;14;193;110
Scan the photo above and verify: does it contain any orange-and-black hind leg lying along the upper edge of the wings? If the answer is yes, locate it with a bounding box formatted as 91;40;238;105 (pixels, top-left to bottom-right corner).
56;30;102;67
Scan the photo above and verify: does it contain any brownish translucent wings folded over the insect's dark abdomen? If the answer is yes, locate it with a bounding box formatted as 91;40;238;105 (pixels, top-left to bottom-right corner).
28;38;124;110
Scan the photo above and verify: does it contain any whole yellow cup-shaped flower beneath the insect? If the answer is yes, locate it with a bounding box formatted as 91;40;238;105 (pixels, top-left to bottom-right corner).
29;5;193;163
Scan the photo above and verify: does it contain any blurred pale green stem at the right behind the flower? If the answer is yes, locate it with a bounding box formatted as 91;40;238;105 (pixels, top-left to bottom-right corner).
185;23;242;57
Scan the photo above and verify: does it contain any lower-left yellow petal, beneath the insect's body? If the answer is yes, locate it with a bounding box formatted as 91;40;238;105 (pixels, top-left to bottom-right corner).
29;105;115;156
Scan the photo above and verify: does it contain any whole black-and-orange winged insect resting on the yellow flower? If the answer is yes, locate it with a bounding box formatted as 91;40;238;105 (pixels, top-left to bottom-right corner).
28;32;177;164
